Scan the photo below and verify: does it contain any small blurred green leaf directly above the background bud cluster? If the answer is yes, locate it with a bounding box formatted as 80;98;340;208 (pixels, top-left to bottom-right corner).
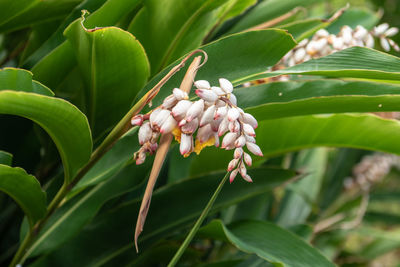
327;8;380;34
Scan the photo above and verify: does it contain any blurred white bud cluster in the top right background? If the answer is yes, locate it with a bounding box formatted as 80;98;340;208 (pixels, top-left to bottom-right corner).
282;23;400;67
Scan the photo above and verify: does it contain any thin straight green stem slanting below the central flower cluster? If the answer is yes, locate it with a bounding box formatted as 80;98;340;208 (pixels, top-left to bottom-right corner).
168;172;229;267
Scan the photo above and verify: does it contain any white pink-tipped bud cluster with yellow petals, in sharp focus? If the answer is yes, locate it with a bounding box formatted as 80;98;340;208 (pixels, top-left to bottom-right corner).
131;78;263;182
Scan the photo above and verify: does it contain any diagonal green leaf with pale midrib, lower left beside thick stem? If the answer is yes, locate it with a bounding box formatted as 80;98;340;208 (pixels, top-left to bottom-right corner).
23;163;150;256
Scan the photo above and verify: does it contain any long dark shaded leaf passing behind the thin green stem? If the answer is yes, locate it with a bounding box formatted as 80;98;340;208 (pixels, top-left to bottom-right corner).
29;169;296;266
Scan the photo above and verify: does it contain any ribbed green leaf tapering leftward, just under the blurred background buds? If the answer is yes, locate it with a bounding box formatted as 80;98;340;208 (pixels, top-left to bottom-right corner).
241;47;400;82
